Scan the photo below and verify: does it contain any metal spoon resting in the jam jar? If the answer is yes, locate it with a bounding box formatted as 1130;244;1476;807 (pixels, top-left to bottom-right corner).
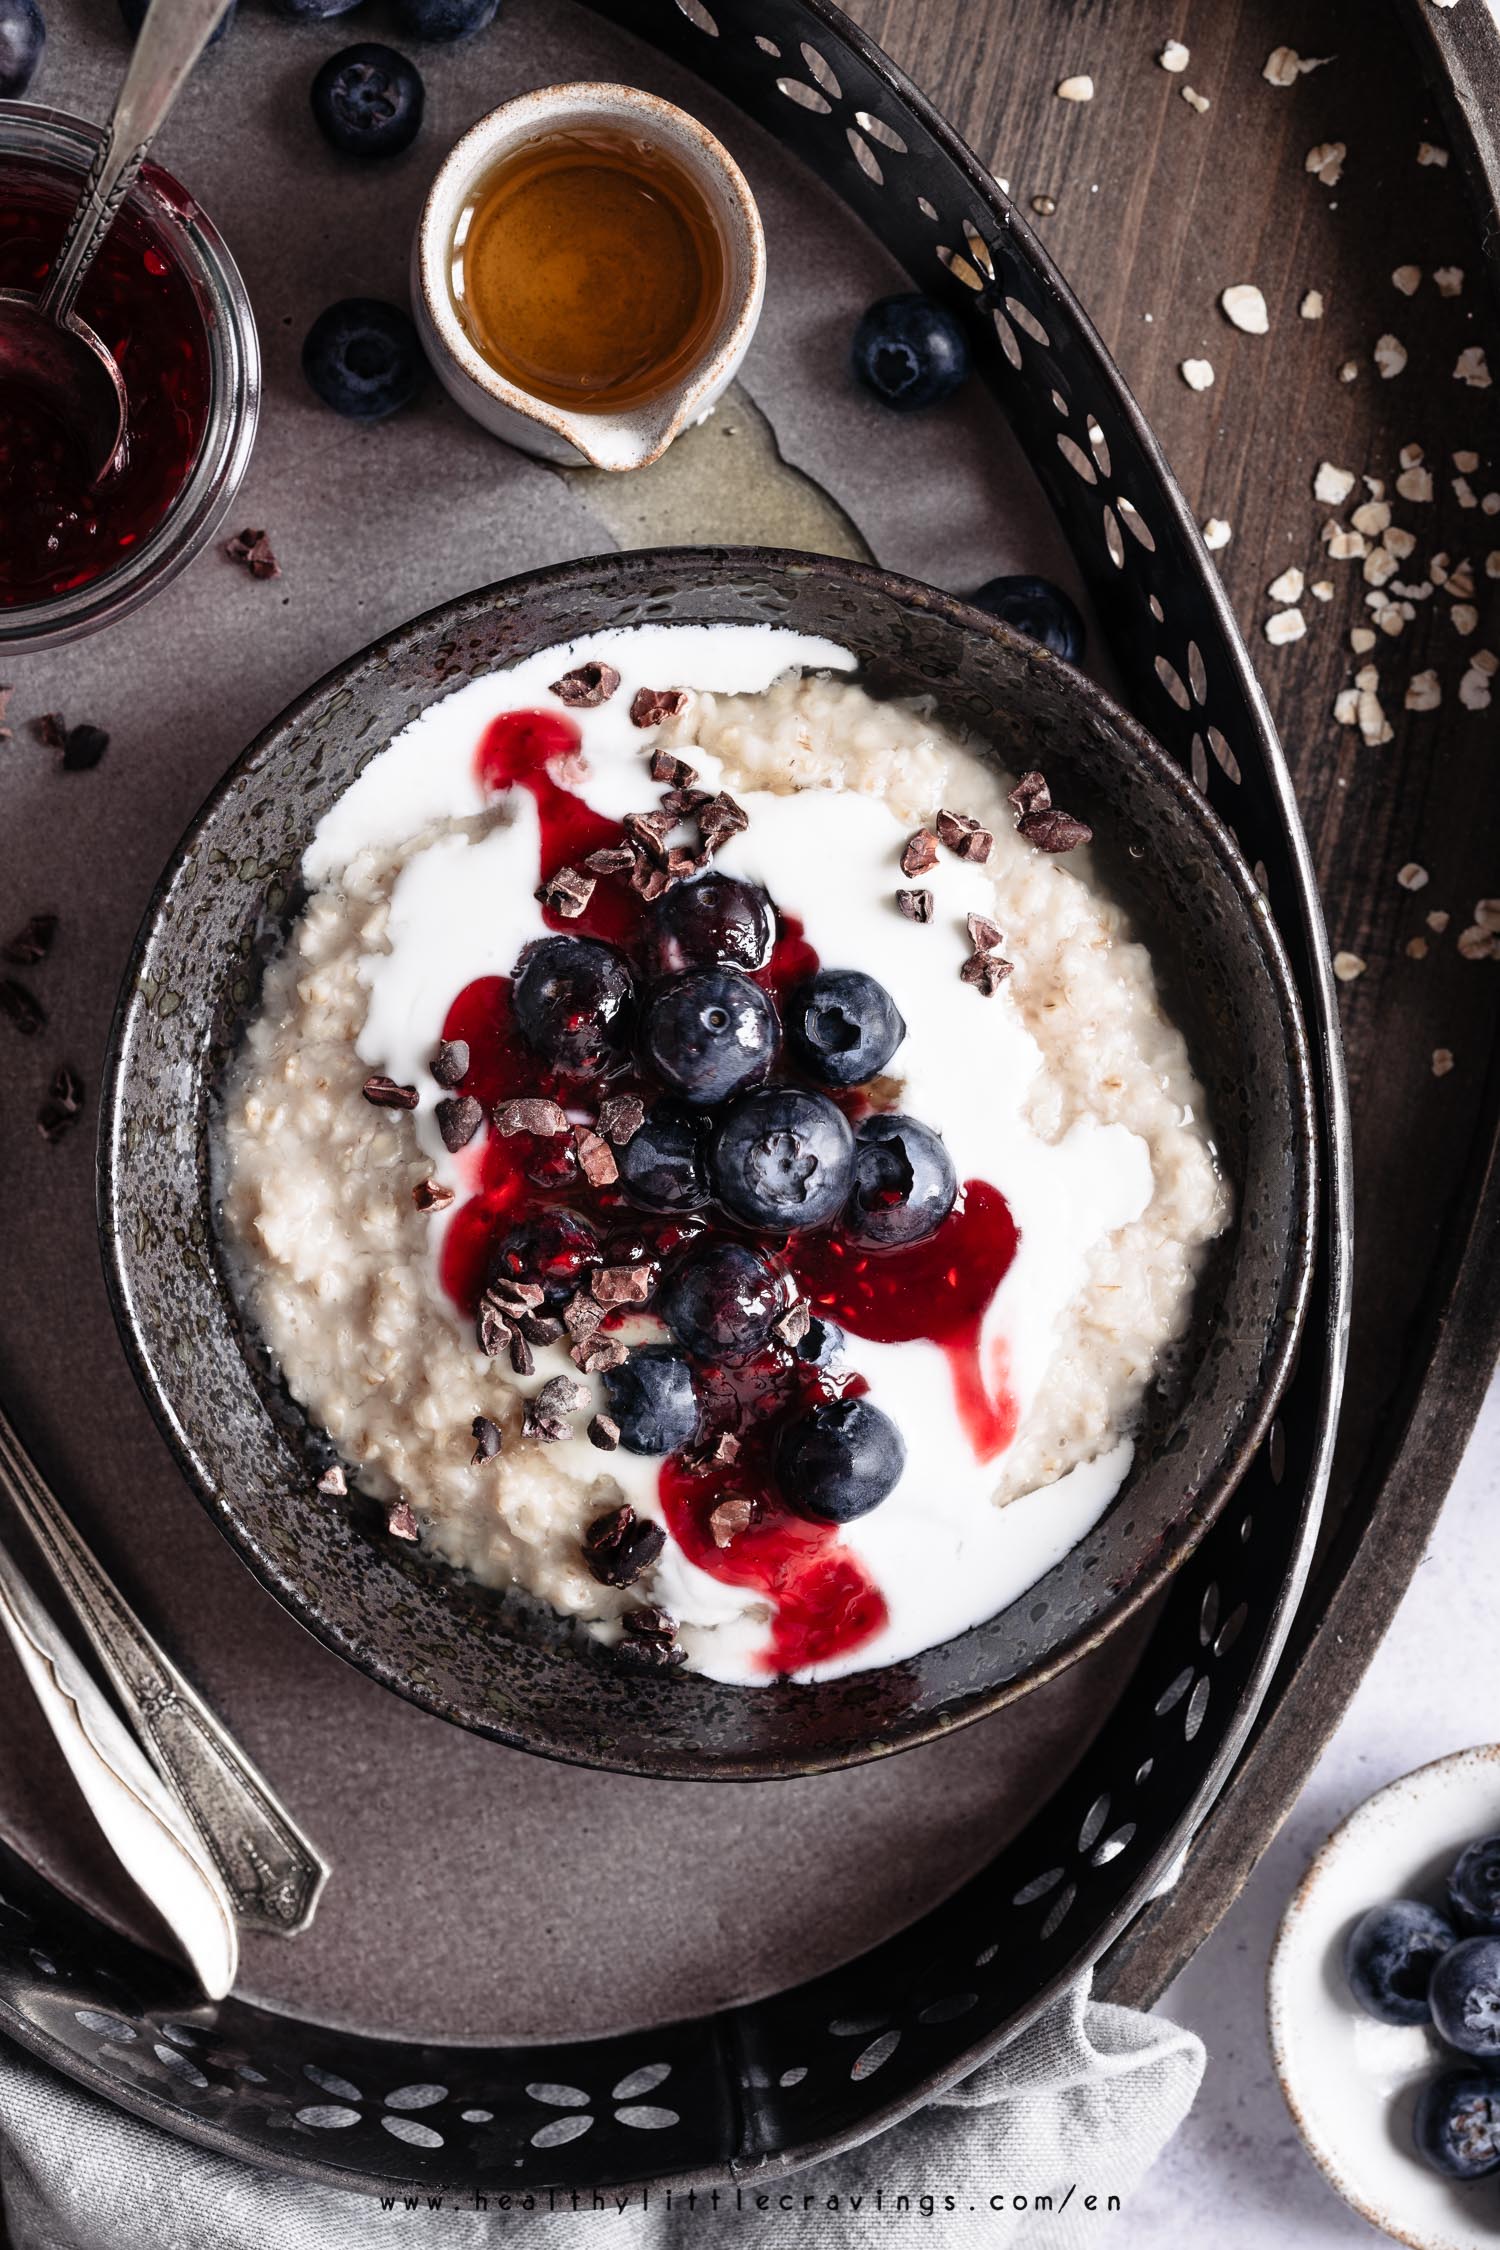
0;0;225;484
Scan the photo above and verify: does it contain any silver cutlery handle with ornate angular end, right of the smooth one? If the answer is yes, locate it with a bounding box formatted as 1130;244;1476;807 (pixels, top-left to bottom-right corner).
0;1413;328;1937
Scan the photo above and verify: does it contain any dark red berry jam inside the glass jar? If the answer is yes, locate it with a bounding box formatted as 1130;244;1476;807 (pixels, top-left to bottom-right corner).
0;164;209;608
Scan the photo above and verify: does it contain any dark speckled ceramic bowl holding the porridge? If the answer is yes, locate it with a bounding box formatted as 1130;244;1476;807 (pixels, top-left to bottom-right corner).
99;549;1316;1780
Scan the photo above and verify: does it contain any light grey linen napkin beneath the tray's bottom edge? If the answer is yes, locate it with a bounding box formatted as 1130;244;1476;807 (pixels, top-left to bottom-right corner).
0;1982;1203;2250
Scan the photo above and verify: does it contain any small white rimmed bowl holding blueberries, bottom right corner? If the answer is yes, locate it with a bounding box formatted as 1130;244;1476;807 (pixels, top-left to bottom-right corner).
1266;1744;1500;2250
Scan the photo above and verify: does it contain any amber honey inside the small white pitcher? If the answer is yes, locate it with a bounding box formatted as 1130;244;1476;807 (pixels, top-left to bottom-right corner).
450;128;726;414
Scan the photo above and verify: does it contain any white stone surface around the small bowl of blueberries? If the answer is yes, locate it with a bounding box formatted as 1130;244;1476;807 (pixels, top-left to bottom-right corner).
1109;1382;1500;2250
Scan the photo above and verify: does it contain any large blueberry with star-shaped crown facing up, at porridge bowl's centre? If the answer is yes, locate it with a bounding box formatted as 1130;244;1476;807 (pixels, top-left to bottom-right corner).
708;1087;855;1235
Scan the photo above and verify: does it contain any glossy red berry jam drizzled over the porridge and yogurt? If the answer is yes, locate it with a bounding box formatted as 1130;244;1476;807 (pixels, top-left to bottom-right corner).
441;711;1016;1674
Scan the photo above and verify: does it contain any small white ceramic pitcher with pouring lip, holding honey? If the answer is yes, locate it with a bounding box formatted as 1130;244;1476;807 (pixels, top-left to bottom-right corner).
412;83;765;468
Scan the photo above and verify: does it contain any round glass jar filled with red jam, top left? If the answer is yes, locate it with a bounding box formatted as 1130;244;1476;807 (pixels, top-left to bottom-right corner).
0;106;261;653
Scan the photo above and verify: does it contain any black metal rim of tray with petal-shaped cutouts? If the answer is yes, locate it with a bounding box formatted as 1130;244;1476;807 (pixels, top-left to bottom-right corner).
0;0;1349;2192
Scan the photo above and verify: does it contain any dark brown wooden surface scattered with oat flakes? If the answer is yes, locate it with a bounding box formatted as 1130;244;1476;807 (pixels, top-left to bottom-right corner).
850;0;1500;2000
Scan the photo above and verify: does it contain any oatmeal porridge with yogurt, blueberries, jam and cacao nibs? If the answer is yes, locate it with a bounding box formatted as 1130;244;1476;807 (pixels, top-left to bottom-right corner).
220;626;1228;1685
